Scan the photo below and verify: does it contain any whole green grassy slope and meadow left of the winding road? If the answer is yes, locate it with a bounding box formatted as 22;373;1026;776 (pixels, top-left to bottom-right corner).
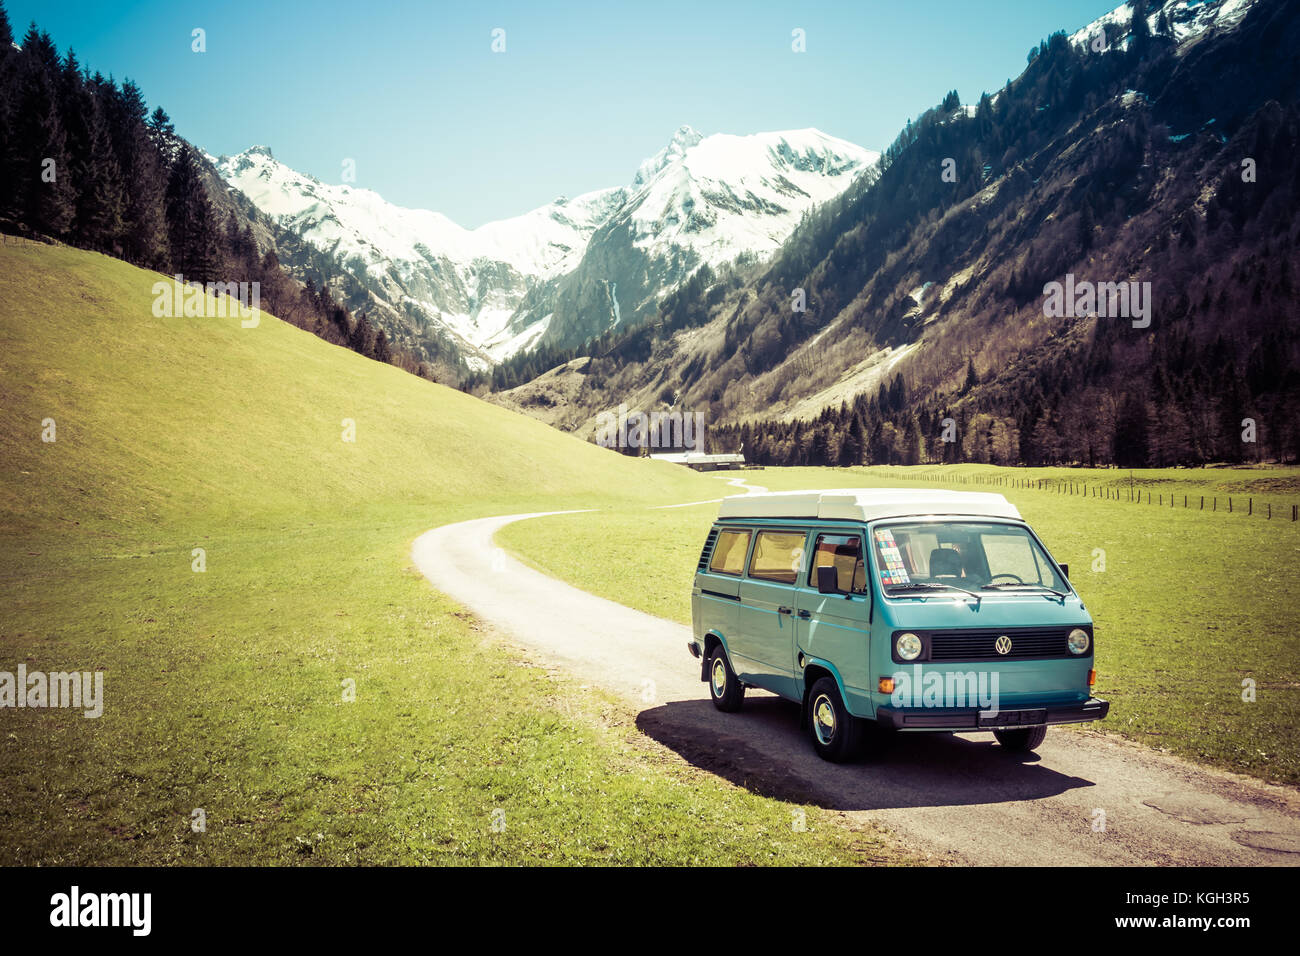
0;246;902;865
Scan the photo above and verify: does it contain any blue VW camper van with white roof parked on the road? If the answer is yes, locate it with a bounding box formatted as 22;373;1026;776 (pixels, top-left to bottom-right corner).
689;489;1110;761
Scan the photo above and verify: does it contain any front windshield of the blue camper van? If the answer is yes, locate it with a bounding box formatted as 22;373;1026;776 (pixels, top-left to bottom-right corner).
871;522;1070;592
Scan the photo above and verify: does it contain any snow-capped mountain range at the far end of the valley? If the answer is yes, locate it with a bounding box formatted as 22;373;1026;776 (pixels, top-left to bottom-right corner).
215;126;878;367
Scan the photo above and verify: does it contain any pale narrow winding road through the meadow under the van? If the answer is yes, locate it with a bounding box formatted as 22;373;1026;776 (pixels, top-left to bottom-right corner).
412;479;1300;865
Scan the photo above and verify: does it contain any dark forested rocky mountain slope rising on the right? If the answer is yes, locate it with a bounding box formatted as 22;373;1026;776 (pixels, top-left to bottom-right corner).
488;0;1300;463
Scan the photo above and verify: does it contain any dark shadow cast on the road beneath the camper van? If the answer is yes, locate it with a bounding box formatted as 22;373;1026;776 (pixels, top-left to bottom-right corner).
636;696;1096;810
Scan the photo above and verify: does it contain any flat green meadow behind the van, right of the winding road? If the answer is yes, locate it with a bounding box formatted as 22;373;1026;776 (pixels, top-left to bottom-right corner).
498;466;1300;783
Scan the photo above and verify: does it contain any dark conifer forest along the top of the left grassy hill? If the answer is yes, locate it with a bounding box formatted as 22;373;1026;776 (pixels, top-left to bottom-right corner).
0;3;432;377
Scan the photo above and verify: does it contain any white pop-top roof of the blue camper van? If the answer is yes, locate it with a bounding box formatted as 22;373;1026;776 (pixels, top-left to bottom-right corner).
718;488;1021;522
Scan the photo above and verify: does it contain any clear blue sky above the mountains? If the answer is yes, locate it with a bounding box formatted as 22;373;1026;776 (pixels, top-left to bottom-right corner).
4;0;1119;226
